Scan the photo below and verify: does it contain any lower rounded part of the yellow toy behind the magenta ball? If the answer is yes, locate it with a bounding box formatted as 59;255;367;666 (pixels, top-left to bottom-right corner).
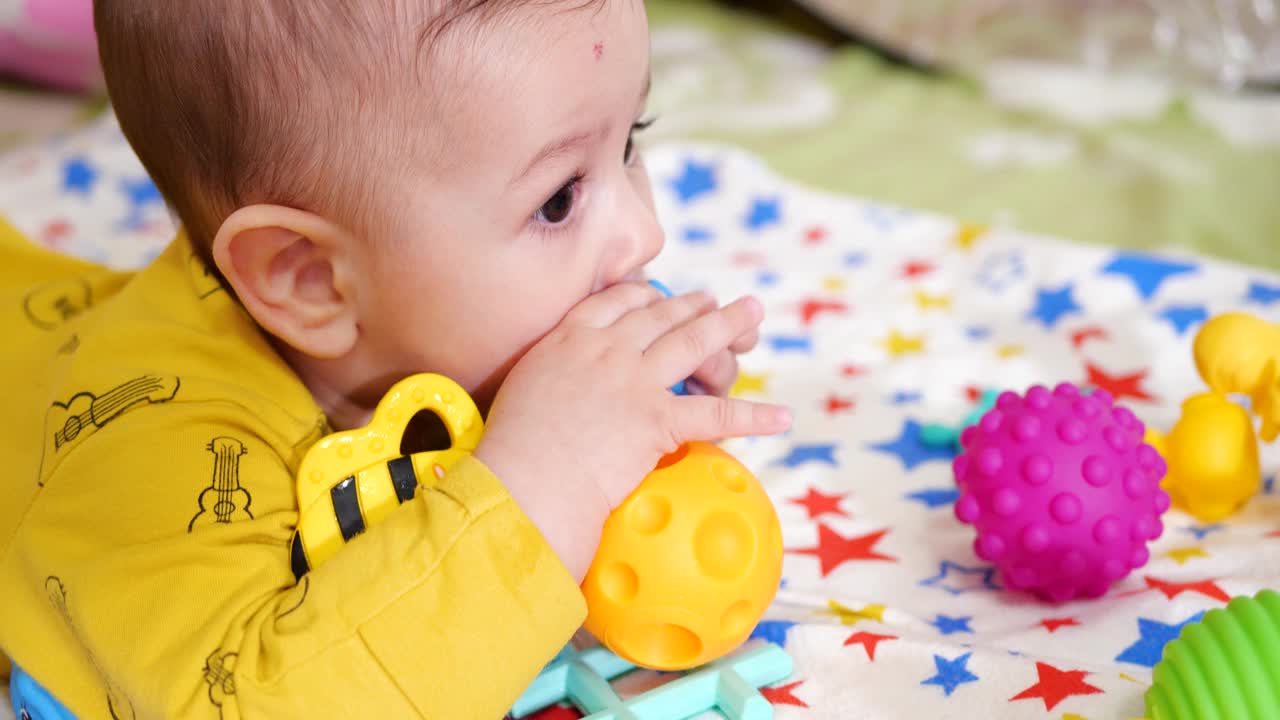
1147;392;1262;523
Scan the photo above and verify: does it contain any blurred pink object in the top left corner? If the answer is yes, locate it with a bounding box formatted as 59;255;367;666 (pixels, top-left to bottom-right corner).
0;0;101;91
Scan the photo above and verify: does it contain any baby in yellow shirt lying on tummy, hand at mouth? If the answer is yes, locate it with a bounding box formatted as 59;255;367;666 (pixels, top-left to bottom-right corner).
0;0;790;720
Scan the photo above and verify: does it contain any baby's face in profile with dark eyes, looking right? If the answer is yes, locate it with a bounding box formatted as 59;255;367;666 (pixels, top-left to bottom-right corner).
360;0;663;406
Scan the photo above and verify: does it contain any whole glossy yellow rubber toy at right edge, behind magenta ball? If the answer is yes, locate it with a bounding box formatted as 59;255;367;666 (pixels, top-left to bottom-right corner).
1147;313;1280;523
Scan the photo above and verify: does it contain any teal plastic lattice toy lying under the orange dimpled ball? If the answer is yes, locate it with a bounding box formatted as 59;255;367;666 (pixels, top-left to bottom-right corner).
511;643;794;720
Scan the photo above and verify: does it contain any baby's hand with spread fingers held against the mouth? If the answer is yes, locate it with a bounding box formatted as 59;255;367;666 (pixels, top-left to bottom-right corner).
476;283;791;580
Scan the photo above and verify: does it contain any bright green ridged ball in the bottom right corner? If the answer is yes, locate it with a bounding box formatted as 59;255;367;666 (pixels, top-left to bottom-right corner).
1146;591;1280;720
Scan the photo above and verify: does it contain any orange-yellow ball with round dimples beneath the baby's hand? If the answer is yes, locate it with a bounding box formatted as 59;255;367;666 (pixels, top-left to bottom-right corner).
582;442;782;670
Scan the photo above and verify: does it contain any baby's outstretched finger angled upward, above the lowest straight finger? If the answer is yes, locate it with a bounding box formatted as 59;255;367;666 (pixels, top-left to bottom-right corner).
645;297;764;384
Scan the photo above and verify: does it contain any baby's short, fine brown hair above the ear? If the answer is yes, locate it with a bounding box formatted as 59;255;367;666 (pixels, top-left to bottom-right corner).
93;0;599;277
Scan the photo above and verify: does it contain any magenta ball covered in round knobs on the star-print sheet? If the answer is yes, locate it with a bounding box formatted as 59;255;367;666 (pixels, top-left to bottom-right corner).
955;383;1169;602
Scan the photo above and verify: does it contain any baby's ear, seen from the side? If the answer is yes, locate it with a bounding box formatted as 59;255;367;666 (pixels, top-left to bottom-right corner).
212;205;360;359
